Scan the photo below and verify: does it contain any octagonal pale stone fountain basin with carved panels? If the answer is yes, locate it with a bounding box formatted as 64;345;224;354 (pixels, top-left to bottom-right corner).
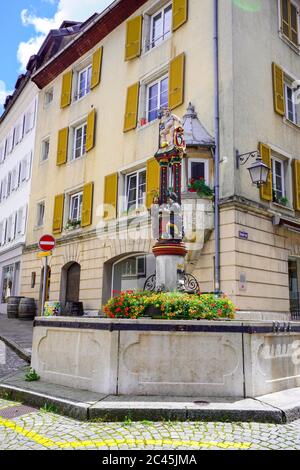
32;317;300;397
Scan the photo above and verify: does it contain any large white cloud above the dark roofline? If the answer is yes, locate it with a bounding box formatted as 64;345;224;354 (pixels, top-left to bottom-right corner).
17;0;112;71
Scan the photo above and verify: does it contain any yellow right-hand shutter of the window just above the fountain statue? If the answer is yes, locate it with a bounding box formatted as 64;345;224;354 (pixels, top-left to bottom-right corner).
169;54;185;109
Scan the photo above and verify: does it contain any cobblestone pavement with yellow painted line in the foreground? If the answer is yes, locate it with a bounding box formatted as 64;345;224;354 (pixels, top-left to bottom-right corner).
0;399;300;450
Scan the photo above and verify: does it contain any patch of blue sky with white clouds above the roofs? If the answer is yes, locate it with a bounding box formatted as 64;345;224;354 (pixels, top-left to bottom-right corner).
0;0;112;114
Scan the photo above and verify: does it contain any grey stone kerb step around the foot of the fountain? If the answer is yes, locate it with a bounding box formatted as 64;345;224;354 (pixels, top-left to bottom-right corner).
0;383;290;424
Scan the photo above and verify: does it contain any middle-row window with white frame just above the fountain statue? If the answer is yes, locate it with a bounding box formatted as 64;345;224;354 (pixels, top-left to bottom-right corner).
147;76;169;122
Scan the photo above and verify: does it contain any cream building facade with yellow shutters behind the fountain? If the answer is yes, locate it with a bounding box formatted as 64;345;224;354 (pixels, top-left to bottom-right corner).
21;0;300;319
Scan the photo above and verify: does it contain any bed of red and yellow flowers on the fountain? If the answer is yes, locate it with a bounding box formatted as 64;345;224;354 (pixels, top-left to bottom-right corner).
104;291;236;320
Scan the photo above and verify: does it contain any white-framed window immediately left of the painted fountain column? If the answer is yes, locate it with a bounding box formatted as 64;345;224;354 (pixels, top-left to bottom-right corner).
126;170;146;212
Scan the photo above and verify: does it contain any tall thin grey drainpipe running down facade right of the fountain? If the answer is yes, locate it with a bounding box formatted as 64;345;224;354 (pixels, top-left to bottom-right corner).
214;0;221;294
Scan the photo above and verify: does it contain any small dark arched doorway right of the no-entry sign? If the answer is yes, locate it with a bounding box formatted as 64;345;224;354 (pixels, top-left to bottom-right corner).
60;262;81;306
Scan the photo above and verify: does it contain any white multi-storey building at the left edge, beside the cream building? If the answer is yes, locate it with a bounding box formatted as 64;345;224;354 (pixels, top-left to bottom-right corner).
0;72;38;313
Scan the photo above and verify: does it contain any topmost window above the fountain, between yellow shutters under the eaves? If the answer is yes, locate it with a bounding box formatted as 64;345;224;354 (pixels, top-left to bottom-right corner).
149;4;172;49
